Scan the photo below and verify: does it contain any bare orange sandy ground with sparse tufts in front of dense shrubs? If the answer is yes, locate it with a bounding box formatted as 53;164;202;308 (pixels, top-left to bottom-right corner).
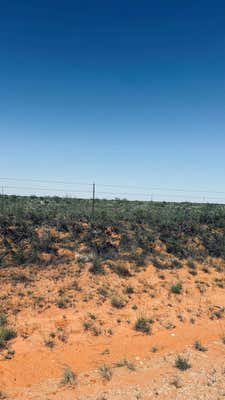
0;264;225;400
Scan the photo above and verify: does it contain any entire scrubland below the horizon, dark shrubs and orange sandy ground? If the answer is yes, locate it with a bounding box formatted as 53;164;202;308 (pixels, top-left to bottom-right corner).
0;196;225;400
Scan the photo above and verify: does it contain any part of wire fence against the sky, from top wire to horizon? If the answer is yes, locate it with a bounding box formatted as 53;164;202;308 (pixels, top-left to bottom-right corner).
0;177;225;204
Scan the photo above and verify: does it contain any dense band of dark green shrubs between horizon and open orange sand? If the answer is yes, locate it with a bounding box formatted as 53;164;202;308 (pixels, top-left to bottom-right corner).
0;195;225;268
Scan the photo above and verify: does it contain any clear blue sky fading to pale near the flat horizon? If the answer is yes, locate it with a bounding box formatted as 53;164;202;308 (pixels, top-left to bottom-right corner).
0;0;225;201
